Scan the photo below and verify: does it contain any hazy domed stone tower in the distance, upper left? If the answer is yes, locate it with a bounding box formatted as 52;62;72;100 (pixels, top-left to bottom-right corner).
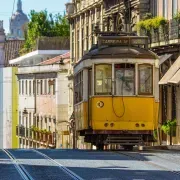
8;0;29;39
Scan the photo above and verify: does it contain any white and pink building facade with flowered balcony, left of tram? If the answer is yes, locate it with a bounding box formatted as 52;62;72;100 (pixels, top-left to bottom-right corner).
17;64;69;148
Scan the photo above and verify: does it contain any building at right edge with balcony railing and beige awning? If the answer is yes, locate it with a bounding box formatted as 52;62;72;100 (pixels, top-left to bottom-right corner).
150;0;180;144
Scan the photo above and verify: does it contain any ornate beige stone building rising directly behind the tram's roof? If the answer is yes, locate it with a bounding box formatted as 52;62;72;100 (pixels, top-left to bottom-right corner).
66;0;157;62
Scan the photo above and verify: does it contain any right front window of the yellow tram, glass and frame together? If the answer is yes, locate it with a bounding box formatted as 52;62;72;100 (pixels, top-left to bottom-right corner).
138;65;153;95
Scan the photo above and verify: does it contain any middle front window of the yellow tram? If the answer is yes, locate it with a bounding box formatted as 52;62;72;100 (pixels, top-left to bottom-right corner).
114;64;135;95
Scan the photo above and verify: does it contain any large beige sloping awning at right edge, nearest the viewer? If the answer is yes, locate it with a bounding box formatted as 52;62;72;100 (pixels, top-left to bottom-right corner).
159;56;180;85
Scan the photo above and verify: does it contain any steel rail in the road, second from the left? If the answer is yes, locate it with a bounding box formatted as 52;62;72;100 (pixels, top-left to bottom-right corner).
32;149;84;180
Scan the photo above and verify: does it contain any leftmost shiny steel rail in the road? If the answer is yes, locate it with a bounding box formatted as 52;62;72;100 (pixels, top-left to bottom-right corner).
3;149;34;180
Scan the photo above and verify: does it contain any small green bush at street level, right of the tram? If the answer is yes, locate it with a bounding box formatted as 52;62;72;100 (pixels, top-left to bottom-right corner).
161;119;177;135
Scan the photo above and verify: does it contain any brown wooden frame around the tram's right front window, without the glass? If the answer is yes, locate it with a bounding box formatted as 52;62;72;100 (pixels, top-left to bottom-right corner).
137;63;154;96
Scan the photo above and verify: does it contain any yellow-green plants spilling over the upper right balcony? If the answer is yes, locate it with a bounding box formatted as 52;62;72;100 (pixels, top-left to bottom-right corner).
137;17;168;31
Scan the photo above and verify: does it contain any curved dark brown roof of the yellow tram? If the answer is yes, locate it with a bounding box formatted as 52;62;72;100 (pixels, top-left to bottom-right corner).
79;46;158;62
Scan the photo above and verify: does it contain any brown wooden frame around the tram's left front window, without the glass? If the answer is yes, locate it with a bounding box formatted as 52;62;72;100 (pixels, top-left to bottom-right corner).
93;63;114;96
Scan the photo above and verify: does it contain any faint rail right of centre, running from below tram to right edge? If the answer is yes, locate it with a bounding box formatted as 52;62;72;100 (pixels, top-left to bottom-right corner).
115;151;180;175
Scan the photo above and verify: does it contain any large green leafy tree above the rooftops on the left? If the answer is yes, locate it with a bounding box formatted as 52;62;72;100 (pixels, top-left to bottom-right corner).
20;10;70;54
